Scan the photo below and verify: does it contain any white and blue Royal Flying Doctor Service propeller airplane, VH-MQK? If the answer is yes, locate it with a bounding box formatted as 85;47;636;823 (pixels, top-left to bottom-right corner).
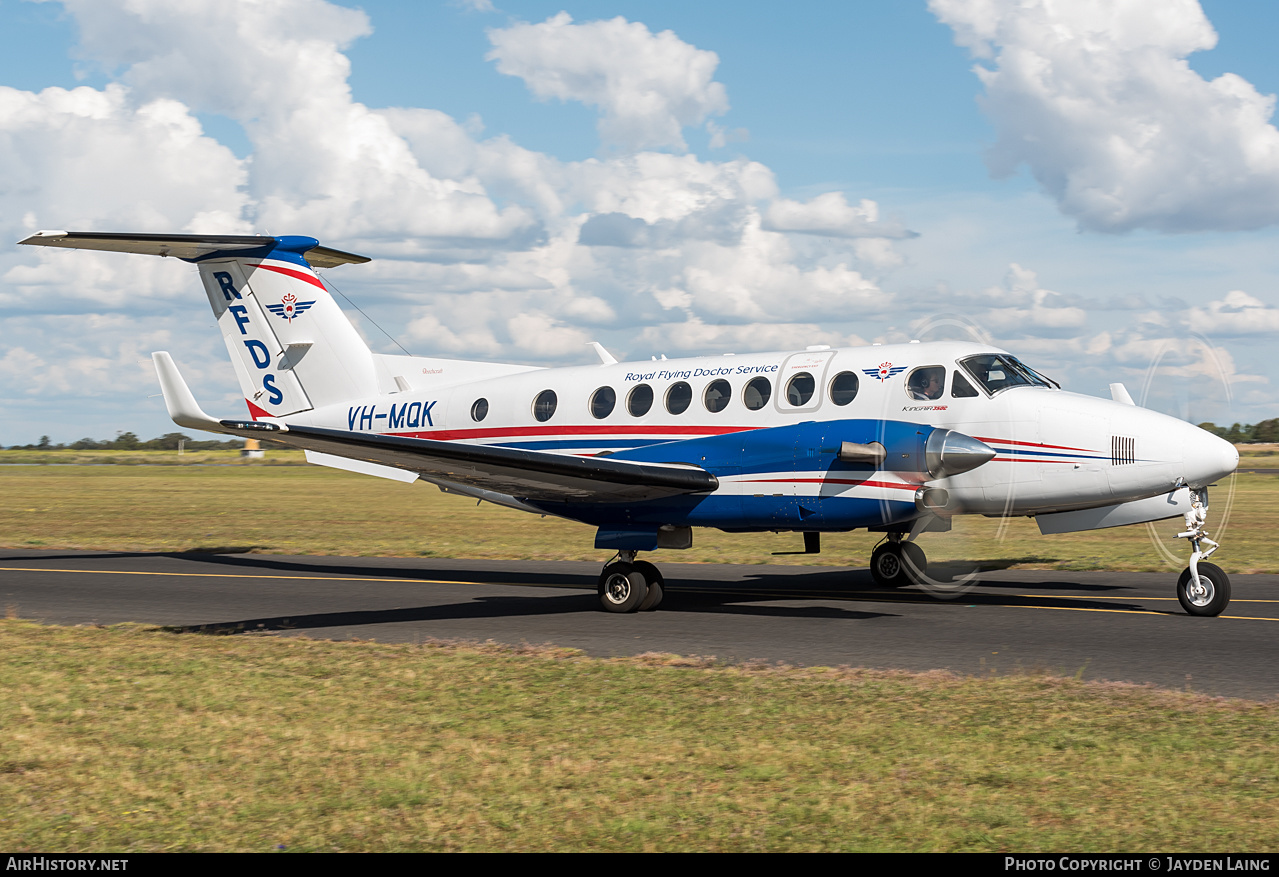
19;231;1239;616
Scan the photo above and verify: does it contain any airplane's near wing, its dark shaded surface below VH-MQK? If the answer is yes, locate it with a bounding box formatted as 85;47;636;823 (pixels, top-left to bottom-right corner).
220;421;719;502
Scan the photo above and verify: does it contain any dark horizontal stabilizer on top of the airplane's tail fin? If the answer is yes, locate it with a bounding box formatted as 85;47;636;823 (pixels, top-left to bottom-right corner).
18;231;371;268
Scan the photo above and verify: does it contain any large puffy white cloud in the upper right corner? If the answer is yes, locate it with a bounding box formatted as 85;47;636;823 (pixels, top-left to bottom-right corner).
929;0;1279;231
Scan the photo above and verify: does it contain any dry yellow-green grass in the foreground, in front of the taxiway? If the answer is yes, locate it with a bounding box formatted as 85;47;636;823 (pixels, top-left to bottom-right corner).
0;620;1279;853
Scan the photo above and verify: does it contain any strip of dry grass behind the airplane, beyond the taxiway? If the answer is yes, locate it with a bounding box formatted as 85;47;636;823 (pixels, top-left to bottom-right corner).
0;446;1279;573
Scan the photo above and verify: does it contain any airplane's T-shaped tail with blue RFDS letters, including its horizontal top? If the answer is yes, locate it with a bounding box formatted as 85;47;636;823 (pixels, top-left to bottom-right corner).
20;231;377;419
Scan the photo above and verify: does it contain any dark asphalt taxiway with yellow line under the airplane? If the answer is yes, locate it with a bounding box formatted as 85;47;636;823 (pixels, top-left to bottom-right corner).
0;550;1279;699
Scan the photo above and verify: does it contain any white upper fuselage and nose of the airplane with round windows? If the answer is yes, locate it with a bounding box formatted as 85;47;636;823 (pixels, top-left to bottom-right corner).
283;341;1238;515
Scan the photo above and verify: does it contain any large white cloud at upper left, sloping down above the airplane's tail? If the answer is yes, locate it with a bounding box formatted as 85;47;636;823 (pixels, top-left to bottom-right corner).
53;0;540;252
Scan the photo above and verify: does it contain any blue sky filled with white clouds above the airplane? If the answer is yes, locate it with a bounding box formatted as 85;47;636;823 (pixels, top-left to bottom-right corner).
0;0;1279;445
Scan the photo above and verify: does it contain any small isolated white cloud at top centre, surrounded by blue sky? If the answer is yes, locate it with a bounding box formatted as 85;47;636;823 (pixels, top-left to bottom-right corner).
487;12;728;151
